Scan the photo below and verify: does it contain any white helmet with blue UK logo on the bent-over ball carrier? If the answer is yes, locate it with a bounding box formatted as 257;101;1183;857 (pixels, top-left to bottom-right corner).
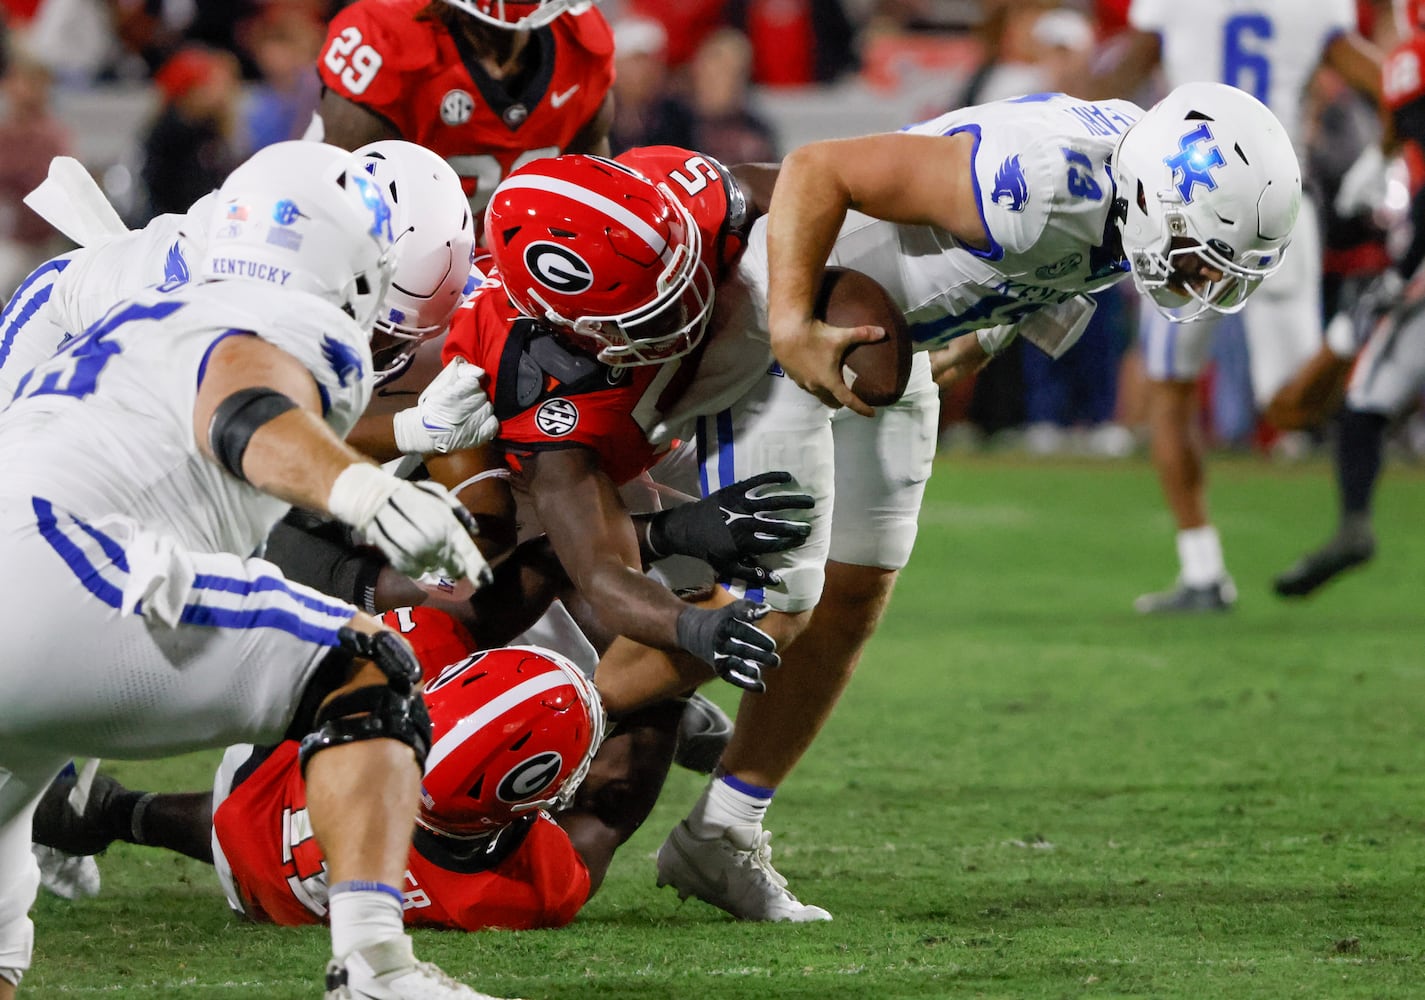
1113;83;1301;321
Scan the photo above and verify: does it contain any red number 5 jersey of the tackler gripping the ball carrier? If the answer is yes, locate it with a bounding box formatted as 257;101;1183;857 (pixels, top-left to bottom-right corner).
445;147;765;484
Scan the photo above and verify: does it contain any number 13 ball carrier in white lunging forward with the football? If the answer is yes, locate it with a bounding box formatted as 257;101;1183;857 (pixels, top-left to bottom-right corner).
478;84;1301;922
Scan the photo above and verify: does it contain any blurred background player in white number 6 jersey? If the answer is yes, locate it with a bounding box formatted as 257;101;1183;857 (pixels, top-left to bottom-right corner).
1077;0;1381;614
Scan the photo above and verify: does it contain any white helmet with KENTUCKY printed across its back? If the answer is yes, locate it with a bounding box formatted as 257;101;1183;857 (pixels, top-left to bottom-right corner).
198;140;393;329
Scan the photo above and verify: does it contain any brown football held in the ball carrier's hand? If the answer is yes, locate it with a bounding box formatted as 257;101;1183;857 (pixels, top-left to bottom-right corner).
817;268;911;406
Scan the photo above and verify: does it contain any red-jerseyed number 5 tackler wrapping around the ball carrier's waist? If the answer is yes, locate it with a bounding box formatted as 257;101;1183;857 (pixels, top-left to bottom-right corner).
433;147;807;711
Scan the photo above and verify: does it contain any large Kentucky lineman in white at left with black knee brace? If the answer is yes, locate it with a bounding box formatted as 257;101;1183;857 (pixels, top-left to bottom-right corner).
0;142;507;997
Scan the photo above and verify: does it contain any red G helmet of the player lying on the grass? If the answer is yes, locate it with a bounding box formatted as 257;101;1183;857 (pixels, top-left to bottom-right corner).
416;645;604;836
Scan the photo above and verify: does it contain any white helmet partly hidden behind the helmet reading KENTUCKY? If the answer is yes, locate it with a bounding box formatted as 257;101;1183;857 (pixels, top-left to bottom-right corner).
356;140;475;377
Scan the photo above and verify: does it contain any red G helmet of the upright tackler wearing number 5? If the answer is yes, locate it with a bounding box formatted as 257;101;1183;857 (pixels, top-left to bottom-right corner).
485;155;713;366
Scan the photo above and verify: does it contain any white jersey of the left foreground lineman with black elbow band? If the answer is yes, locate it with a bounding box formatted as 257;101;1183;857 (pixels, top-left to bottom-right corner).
0;282;372;564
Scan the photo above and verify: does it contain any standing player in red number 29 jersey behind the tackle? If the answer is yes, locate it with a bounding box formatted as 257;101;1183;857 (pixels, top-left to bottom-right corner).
312;0;614;208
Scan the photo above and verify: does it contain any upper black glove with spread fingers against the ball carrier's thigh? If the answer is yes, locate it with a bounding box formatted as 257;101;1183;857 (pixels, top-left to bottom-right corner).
648;472;814;587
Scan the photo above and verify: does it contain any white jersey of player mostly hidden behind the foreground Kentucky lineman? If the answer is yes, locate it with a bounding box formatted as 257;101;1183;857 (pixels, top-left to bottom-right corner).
0;194;217;406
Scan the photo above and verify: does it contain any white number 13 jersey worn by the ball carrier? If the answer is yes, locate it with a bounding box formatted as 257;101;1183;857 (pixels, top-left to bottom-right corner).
820;94;1143;350
